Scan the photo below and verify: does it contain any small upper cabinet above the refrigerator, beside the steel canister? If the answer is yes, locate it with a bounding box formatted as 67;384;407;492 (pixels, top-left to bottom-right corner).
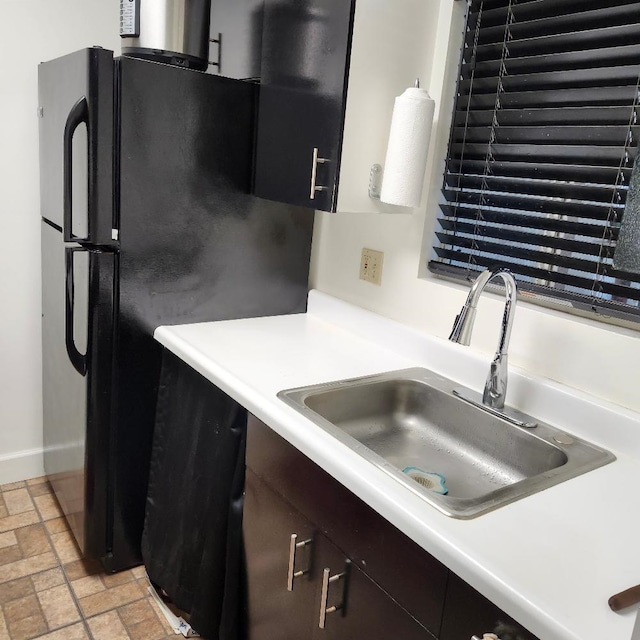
209;0;264;80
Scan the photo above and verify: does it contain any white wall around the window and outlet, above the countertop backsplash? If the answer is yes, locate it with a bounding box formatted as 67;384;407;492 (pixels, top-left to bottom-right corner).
311;0;640;416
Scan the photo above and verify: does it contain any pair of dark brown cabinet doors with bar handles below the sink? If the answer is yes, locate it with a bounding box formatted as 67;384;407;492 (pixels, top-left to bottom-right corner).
244;464;434;640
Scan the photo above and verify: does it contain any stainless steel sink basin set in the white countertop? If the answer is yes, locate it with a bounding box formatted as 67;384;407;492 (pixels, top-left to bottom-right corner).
278;368;615;518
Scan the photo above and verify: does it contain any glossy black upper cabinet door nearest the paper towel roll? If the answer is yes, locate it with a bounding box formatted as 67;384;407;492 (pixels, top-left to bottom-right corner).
255;0;354;211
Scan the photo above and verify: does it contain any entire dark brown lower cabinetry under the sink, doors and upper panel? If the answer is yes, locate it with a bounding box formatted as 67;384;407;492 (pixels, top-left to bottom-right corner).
243;415;537;640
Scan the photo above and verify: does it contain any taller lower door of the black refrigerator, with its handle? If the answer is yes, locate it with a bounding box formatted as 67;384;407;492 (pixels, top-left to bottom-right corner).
42;222;117;557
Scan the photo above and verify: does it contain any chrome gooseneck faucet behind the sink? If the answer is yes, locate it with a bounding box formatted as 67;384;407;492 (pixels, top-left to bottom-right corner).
449;267;517;409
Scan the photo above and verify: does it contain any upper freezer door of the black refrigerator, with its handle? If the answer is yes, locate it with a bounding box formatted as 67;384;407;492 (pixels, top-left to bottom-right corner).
38;48;114;245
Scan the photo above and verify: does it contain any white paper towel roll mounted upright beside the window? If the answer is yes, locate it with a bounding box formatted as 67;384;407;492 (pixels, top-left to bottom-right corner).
380;87;435;207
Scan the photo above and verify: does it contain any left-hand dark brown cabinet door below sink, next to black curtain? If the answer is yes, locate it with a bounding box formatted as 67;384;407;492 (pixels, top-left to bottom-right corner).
243;469;317;640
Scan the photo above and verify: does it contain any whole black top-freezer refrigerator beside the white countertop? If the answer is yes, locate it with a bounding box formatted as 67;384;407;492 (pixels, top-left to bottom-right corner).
38;47;312;571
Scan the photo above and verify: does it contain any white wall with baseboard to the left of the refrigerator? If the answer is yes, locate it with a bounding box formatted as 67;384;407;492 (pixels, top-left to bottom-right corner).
0;0;120;484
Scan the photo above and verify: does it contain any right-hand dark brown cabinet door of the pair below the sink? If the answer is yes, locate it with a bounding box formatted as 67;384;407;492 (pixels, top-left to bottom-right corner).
313;538;434;640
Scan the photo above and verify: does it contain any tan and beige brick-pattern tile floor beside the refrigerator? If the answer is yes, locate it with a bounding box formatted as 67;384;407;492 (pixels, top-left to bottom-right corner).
0;478;175;640
